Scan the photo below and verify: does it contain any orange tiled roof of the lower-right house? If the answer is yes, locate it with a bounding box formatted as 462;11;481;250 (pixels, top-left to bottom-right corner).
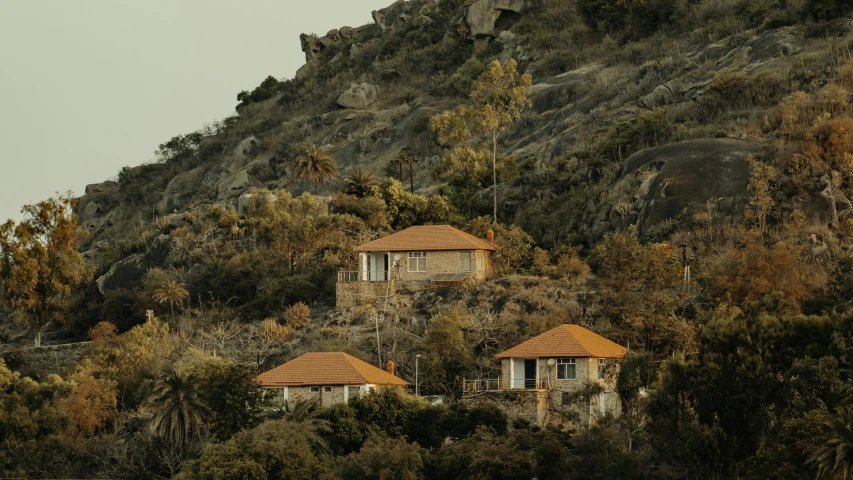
495;325;628;358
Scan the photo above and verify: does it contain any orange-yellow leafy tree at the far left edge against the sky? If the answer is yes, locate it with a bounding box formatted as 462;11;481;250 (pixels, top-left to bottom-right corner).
0;193;88;346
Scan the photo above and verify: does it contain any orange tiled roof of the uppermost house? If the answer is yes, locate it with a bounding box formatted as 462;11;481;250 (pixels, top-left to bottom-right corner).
355;225;497;252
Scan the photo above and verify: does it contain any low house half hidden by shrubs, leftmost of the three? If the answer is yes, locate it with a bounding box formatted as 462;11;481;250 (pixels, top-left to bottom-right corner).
256;352;409;407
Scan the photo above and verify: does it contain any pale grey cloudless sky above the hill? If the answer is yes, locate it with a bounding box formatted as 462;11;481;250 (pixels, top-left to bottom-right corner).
0;0;393;222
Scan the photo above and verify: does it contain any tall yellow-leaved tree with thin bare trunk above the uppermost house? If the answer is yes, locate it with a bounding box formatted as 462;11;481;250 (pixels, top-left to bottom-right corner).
432;60;533;223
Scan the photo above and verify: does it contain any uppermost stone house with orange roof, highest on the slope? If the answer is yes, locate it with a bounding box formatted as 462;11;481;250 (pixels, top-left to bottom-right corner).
336;225;497;308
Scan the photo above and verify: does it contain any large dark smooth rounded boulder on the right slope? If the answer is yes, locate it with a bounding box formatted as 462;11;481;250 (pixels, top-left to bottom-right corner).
622;138;761;238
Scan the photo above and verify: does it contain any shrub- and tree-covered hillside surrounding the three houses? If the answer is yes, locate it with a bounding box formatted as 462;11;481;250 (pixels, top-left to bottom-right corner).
5;0;853;479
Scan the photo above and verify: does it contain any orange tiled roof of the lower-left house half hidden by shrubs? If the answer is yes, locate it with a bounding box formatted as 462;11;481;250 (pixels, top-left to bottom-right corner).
257;352;409;387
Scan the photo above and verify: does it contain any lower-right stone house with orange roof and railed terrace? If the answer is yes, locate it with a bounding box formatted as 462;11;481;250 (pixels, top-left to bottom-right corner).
463;325;627;426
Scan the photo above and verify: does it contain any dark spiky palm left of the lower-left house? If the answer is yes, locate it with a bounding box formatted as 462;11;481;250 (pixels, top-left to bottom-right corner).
147;371;210;445
